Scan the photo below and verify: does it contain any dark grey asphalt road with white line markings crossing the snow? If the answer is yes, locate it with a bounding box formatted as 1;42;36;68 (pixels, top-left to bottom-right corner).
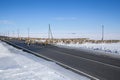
2;40;120;80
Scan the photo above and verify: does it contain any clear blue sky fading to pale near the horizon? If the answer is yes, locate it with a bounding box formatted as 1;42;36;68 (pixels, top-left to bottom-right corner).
0;0;120;39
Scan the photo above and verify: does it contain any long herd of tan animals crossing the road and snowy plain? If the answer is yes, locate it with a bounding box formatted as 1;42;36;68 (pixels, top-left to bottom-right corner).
7;38;120;45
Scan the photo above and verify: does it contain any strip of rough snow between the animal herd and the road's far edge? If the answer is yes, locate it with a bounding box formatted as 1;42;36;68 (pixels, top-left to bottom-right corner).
55;43;120;57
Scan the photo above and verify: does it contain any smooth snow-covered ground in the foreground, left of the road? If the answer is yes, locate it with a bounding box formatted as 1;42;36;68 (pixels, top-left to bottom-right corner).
0;41;90;80
